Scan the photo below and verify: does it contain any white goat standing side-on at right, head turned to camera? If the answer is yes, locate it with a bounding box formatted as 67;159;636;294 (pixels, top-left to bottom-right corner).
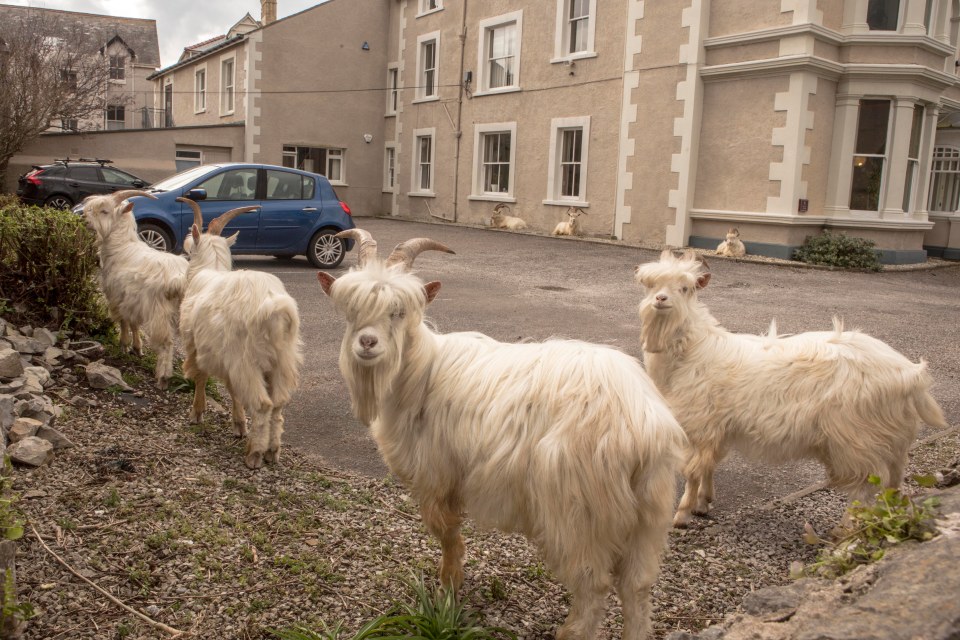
636;250;946;527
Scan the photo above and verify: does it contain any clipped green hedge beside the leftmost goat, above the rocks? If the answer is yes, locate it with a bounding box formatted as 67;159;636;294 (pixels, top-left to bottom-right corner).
0;197;110;334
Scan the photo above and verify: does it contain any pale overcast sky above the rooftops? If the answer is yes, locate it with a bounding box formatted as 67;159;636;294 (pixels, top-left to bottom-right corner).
0;0;324;67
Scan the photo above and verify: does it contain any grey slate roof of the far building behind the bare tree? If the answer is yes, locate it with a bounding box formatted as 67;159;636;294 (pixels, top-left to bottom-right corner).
0;4;160;68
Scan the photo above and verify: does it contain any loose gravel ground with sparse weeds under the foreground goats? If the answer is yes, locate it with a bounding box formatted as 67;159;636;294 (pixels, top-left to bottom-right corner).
14;361;960;640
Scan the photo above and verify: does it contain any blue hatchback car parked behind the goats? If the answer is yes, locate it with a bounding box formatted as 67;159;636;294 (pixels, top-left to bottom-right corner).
114;163;355;269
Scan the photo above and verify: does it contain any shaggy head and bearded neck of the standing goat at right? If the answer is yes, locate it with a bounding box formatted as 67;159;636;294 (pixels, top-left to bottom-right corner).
635;250;710;353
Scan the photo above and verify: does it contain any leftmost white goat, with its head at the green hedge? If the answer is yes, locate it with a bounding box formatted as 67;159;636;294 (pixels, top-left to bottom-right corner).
83;190;187;389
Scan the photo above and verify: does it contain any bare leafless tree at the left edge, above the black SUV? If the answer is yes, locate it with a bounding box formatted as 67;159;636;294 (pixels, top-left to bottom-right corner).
0;11;109;189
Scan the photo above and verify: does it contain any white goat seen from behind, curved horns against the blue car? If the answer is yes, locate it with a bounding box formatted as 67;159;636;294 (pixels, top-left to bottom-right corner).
177;198;303;469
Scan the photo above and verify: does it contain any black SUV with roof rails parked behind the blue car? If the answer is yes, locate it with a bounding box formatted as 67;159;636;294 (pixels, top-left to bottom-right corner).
17;158;149;209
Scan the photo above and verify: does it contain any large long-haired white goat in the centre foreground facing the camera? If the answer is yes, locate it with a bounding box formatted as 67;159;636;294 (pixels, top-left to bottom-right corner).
317;229;685;640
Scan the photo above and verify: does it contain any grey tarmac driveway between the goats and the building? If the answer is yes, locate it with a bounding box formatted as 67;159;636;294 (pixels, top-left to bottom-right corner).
235;218;960;507
